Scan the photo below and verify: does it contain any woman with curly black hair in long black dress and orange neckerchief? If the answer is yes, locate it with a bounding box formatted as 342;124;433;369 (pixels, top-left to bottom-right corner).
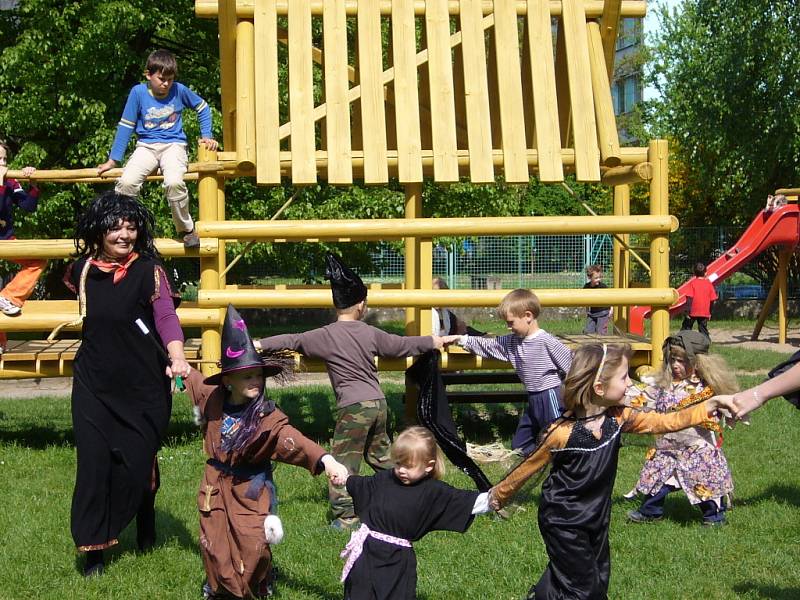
64;192;190;576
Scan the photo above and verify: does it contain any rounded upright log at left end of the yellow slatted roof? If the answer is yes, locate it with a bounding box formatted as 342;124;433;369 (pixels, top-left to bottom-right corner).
236;21;256;170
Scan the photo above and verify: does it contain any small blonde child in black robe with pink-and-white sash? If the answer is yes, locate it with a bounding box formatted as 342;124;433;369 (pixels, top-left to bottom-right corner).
342;427;489;600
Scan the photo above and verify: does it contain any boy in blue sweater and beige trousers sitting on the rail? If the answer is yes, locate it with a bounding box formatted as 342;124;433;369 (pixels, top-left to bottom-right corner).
97;50;217;248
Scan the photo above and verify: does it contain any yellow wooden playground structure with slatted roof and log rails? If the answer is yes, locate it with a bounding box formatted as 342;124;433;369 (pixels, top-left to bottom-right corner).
0;0;677;408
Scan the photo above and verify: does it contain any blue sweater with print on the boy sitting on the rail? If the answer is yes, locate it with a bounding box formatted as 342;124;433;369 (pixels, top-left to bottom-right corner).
108;82;216;162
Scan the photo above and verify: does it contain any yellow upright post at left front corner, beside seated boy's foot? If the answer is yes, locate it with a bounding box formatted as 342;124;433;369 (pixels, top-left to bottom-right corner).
197;146;225;376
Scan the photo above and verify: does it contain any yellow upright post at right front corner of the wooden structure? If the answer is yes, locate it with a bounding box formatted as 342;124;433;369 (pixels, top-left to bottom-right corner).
647;140;670;367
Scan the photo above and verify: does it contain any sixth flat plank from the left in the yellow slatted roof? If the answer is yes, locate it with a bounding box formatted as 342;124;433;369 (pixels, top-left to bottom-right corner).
425;0;458;182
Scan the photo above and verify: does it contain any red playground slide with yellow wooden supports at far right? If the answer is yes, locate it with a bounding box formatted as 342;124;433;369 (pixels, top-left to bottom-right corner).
628;189;800;344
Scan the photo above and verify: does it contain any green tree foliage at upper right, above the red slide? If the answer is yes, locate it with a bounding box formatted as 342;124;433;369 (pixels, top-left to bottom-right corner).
648;0;800;225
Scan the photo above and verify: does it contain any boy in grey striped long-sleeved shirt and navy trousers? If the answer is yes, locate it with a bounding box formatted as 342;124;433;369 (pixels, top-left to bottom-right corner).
442;289;572;455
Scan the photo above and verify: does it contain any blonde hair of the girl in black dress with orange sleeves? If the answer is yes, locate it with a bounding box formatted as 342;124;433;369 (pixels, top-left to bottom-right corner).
564;344;633;411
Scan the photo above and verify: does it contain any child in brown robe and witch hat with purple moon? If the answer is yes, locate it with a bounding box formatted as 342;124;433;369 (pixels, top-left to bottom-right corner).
186;305;347;598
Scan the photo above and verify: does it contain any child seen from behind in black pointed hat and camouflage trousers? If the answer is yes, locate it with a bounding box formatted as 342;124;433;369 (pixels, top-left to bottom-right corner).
257;254;450;530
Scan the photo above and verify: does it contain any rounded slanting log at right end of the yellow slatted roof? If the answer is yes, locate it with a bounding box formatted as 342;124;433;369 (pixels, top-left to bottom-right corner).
586;21;622;167
